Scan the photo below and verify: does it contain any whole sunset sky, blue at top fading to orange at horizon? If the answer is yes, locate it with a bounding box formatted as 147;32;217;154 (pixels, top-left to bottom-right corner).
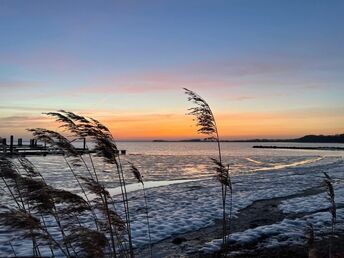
0;0;344;140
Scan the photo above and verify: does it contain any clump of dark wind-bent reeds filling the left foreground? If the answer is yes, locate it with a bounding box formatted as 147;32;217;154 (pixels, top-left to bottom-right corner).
0;110;143;257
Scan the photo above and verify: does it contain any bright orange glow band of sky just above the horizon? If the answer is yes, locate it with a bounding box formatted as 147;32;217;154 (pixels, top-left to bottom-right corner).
0;108;344;141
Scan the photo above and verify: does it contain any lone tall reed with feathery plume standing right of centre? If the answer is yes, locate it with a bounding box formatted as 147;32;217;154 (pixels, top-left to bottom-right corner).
184;88;232;251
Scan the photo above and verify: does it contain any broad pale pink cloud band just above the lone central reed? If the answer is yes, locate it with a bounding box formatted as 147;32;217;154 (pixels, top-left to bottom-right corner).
85;56;326;95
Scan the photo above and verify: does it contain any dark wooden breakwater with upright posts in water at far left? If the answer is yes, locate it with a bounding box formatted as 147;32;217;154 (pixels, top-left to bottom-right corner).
0;135;126;156
